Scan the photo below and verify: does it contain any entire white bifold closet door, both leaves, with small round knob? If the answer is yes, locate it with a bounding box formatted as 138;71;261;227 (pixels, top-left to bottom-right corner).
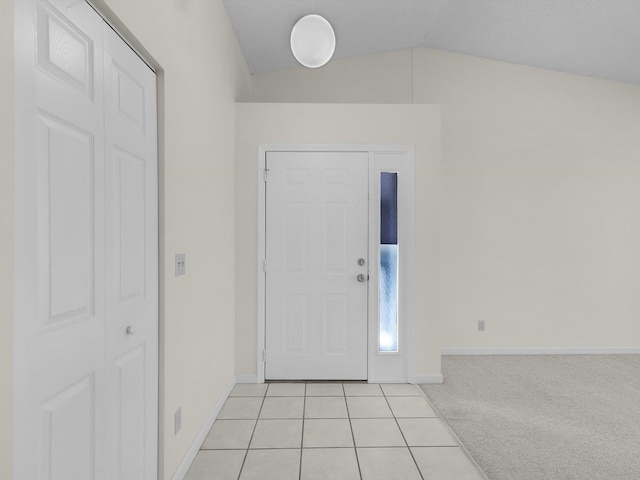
14;0;158;480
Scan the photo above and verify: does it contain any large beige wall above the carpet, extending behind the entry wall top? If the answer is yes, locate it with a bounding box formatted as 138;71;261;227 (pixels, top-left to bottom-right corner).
253;49;640;348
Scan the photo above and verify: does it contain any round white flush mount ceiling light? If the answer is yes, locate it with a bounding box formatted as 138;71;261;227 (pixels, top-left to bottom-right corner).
291;14;336;68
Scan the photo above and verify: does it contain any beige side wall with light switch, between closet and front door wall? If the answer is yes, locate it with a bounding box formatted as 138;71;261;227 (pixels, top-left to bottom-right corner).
99;0;250;479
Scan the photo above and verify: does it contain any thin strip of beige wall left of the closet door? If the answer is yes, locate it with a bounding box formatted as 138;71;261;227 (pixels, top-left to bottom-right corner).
0;1;13;478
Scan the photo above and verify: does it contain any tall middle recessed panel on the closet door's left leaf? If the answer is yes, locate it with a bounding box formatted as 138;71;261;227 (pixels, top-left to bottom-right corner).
38;114;96;327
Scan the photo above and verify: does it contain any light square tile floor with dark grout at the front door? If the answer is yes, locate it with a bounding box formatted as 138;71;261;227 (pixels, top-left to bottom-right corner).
185;383;485;480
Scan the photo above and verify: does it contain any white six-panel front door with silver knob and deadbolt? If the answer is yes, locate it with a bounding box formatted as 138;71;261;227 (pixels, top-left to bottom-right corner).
265;152;369;380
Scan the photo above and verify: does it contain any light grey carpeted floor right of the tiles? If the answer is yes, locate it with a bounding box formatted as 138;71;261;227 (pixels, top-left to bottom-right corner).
422;355;640;480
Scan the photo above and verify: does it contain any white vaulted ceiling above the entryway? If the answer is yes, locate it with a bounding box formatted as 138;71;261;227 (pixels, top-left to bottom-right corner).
224;0;640;84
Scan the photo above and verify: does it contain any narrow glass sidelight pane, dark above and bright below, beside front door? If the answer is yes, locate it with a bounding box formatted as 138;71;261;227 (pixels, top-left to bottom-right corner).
378;172;398;352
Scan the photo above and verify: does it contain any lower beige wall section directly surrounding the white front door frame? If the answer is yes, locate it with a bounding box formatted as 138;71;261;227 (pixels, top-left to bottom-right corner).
236;103;440;375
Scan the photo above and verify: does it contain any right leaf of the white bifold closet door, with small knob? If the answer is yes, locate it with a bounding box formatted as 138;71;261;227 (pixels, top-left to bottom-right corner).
104;22;158;480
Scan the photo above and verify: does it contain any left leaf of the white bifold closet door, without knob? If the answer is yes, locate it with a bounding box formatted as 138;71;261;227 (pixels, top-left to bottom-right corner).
14;1;106;480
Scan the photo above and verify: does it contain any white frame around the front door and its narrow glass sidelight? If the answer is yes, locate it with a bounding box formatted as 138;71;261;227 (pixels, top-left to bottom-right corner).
256;144;415;383
